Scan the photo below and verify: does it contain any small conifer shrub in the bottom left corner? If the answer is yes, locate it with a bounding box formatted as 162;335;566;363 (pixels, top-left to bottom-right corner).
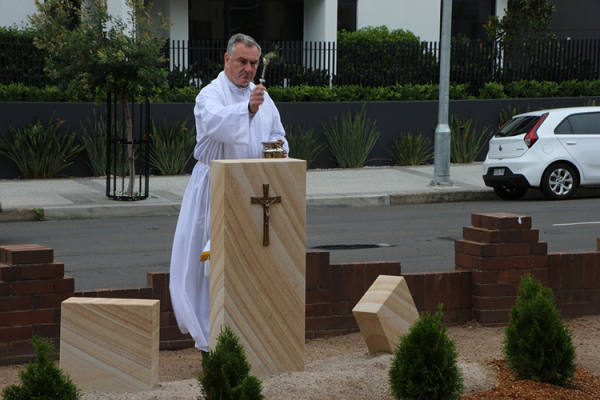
2;336;80;400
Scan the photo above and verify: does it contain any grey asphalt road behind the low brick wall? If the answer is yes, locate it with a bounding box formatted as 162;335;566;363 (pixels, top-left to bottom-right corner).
0;199;600;290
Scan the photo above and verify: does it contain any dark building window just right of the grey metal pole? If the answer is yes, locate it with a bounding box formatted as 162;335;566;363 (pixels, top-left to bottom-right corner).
452;0;496;40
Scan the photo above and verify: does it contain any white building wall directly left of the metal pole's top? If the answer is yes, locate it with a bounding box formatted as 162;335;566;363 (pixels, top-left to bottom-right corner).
356;0;442;41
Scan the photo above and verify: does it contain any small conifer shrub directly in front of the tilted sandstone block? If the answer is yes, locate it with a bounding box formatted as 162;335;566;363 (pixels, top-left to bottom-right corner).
388;304;464;400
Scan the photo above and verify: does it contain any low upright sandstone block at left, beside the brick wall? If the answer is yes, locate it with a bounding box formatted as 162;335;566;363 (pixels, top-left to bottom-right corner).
60;297;160;392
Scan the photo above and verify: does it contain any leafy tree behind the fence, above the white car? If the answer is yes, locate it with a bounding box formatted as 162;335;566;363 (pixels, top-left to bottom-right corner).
484;0;556;41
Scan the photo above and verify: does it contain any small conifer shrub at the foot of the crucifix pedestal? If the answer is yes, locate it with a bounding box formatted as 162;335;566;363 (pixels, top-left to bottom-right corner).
198;326;264;400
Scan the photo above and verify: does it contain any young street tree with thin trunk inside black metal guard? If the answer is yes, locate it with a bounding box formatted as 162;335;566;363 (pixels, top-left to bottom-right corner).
29;0;170;196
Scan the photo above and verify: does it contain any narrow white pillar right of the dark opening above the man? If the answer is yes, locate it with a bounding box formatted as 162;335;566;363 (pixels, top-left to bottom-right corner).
304;0;337;42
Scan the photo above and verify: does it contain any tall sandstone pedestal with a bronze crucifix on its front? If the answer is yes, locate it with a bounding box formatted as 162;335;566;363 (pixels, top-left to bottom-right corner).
210;159;306;377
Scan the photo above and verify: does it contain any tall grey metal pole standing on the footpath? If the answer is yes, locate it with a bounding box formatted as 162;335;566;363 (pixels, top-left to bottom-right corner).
431;0;452;186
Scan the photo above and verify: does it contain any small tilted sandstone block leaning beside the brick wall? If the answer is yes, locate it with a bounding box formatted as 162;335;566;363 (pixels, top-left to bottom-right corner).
352;275;419;353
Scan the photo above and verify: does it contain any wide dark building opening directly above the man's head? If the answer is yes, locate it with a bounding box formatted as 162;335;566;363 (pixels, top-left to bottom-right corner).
189;0;304;41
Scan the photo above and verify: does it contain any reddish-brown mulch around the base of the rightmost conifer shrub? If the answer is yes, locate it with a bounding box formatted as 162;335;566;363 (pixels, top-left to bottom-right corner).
461;360;600;400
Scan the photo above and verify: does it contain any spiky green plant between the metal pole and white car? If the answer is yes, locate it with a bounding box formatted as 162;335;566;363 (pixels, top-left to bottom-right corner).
450;115;493;164
